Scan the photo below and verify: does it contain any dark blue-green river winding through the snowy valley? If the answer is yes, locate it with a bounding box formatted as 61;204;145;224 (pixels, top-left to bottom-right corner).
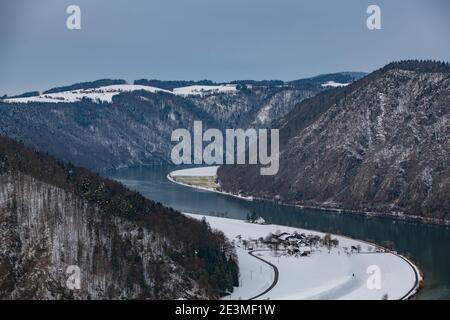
108;166;450;299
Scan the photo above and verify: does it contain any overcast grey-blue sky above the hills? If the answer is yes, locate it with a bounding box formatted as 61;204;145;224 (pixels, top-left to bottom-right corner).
0;0;450;95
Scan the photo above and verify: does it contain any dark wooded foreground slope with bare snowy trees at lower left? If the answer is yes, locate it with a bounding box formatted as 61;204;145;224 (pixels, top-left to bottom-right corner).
0;136;238;299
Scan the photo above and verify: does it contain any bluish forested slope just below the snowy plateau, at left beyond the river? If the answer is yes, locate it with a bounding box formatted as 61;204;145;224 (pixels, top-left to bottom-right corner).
0;91;215;171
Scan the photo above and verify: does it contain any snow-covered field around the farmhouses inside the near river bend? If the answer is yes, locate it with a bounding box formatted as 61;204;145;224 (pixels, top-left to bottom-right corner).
187;214;421;300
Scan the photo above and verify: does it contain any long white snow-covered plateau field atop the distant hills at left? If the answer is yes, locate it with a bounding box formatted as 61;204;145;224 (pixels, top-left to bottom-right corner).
4;84;237;103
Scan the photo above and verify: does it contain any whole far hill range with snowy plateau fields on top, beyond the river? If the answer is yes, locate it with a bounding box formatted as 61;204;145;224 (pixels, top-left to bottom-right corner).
0;71;360;171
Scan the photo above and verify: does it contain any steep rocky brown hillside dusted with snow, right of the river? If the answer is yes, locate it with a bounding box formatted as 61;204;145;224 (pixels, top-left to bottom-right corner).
218;61;450;222
